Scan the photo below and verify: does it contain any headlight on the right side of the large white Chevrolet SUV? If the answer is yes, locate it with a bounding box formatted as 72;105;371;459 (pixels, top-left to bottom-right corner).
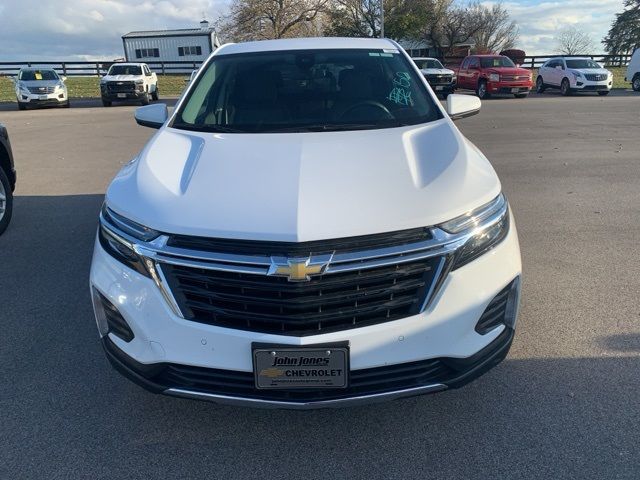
439;194;509;269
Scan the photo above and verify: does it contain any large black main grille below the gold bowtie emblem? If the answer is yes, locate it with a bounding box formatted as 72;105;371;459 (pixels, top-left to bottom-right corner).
162;258;440;336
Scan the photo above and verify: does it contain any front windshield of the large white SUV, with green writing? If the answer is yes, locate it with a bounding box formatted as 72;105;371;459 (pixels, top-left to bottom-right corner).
172;49;441;133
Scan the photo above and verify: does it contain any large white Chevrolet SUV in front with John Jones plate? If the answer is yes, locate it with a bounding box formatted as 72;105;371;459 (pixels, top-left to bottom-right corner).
90;38;521;408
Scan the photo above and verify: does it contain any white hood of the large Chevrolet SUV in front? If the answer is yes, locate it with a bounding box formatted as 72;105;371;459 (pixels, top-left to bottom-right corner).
106;119;501;241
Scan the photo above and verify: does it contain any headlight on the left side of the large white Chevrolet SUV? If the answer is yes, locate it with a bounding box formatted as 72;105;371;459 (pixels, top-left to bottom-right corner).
98;204;160;278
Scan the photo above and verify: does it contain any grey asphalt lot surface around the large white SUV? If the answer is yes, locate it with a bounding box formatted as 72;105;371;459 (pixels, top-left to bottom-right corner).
0;94;640;479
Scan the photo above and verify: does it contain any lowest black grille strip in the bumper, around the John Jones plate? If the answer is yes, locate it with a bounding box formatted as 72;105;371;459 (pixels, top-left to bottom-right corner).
153;359;456;401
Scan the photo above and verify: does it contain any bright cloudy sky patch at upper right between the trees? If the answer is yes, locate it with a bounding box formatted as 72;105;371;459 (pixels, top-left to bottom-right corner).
498;0;623;55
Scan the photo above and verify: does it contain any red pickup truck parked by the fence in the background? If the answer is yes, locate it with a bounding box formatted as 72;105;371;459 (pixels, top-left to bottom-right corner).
457;55;533;99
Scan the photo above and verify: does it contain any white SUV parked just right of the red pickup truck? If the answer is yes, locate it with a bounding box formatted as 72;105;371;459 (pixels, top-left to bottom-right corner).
536;57;613;95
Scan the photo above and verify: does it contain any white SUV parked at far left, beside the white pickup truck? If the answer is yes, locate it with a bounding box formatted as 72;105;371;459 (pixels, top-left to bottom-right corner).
15;68;70;110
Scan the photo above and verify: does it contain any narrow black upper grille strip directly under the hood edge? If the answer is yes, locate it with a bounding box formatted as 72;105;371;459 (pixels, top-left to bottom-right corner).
167;228;432;257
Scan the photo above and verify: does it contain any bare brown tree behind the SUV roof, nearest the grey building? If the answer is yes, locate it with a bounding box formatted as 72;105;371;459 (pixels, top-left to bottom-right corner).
218;0;329;41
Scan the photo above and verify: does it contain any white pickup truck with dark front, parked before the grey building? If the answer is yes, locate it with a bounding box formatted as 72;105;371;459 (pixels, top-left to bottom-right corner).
100;63;158;107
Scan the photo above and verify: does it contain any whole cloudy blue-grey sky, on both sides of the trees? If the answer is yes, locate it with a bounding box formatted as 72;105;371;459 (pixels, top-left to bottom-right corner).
0;0;623;61
